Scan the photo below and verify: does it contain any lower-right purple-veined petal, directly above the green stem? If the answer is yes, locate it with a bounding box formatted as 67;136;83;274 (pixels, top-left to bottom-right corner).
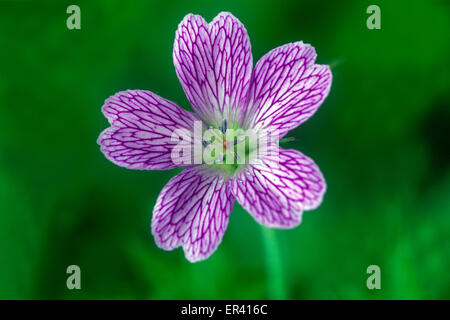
232;147;326;228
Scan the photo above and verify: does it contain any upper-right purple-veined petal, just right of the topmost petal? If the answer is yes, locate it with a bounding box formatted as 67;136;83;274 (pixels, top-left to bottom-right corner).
248;42;332;138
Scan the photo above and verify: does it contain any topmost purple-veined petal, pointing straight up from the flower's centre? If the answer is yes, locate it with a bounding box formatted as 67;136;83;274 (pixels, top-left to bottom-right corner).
173;12;253;127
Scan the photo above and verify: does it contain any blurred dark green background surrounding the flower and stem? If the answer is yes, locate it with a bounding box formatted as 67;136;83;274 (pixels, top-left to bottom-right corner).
0;0;450;299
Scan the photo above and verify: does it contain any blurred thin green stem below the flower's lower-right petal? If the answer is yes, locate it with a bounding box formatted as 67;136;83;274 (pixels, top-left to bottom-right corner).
262;227;286;300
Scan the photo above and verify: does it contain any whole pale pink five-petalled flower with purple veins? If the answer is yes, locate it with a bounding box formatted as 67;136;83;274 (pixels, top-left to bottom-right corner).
98;12;332;262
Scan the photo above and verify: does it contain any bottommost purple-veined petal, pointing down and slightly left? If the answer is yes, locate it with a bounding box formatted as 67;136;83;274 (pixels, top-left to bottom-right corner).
152;167;234;262
